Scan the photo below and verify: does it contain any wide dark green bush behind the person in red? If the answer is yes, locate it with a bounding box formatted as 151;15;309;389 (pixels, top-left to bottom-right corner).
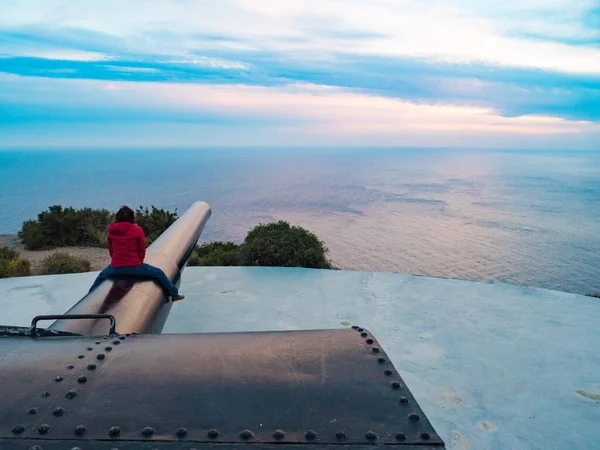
18;205;177;250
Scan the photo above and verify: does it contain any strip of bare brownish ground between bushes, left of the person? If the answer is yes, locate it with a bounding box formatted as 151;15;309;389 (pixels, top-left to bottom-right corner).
0;234;110;275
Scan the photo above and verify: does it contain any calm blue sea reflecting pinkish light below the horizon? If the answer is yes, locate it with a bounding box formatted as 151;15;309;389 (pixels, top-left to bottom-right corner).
0;149;600;293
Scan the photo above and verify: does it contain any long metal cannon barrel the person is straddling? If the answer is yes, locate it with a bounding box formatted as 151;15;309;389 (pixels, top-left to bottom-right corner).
49;202;211;336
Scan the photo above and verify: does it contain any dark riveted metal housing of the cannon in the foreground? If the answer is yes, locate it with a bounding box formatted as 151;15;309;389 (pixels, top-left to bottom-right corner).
0;329;443;450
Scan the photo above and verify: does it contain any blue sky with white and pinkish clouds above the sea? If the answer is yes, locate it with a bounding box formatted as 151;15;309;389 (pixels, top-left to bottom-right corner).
0;0;600;150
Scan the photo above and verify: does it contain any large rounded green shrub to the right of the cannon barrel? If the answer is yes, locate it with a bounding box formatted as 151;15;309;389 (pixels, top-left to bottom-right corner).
239;221;331;269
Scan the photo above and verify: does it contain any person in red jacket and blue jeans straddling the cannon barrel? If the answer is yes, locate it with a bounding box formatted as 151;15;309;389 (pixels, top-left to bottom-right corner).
90;206;185;301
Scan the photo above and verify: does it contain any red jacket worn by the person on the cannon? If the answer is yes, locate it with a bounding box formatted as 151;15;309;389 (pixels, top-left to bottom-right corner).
108;222;146;267
